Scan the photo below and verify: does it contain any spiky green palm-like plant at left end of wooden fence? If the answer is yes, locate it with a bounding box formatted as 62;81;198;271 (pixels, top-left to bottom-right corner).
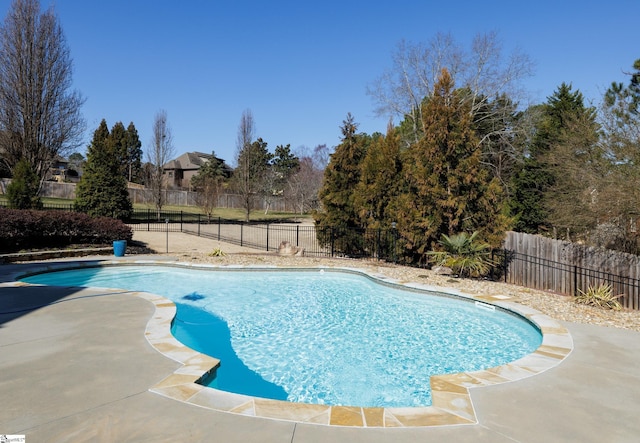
427;231;493;277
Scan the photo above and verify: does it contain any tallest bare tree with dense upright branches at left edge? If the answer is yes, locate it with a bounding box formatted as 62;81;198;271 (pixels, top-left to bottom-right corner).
0;0;85;184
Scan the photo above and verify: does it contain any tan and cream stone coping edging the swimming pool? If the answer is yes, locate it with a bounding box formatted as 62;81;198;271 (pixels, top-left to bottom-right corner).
17;260;573;428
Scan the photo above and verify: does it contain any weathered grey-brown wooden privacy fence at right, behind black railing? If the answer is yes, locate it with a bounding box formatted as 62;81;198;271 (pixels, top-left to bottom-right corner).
504;232;640;309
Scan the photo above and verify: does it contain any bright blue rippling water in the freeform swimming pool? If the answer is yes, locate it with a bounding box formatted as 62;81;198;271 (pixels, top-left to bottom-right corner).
23;266;542;407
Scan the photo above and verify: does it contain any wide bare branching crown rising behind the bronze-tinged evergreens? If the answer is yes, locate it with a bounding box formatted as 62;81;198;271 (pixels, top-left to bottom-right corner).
367;32;533;154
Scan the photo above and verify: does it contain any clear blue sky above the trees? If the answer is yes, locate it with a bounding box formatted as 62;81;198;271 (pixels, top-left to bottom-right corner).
0;0;640;164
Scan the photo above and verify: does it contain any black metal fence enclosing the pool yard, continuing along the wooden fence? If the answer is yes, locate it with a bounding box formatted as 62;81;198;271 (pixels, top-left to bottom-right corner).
3;204;640;309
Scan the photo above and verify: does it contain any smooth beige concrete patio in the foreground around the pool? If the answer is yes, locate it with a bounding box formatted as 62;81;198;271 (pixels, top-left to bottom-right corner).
0;253;640;443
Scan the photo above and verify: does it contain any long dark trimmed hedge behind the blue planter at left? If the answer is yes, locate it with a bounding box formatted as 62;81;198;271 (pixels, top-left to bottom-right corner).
0;208;133;252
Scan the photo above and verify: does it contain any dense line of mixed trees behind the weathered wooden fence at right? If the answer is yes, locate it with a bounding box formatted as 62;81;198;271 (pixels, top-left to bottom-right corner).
315;34;640;262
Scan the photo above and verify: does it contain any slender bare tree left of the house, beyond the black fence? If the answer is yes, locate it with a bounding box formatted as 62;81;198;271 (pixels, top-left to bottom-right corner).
147;110;175;218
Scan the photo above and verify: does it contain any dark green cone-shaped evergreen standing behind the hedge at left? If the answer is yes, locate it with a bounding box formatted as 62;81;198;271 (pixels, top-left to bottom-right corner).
74;120;132;219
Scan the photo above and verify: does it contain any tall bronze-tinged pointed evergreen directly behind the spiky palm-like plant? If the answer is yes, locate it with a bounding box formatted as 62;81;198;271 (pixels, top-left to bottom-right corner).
392;69;509;260
